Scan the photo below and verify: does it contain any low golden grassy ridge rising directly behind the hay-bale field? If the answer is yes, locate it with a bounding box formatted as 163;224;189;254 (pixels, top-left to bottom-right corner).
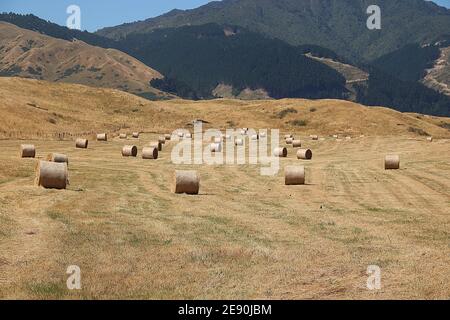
0;77;450;139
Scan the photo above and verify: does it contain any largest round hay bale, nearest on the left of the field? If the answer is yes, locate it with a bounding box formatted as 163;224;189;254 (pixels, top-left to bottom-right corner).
36;161;68;189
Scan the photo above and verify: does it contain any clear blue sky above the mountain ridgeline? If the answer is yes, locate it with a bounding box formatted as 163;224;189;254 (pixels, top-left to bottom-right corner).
0;0;450;31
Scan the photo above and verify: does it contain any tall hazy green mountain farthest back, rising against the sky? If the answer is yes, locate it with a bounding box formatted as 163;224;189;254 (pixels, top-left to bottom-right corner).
97;0;450;61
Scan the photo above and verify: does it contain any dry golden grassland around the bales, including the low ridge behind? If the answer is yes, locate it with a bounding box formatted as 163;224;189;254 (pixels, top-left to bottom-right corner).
0;79;450;299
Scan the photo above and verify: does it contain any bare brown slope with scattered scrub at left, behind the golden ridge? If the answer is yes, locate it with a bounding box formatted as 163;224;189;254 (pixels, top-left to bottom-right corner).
0;22;167;98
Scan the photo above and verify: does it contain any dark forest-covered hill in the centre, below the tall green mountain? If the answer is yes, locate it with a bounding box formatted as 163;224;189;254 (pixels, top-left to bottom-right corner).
119;24;345;98
